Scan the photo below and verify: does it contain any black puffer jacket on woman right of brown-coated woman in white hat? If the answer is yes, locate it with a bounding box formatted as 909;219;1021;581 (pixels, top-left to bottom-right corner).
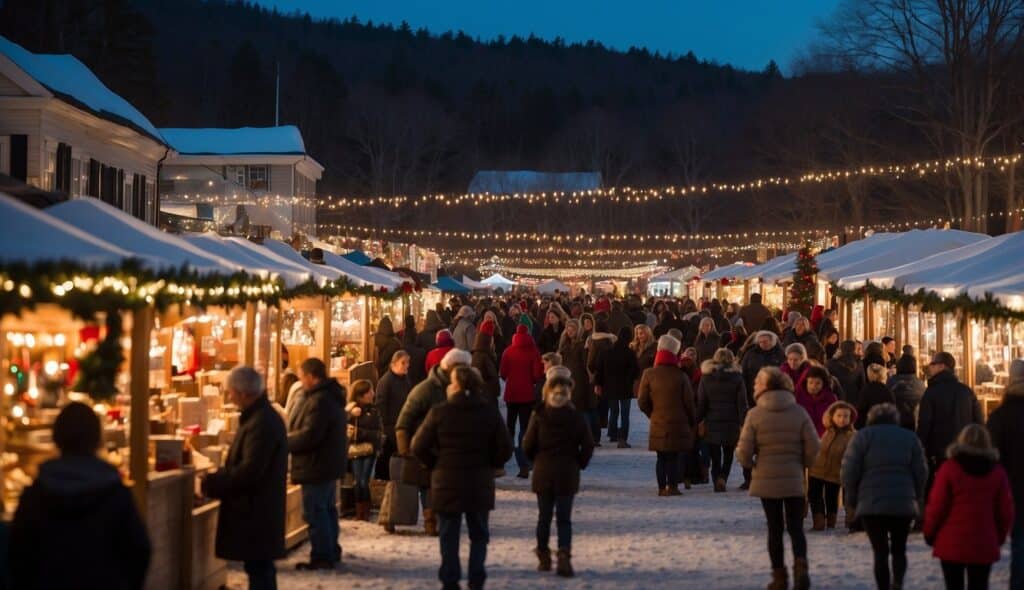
697;361;748;447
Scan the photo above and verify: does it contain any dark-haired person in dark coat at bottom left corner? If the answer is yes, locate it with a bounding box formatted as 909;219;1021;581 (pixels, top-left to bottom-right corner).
11;403;150;590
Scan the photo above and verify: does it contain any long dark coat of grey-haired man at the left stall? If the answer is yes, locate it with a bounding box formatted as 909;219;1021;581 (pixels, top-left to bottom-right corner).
206;397;288;561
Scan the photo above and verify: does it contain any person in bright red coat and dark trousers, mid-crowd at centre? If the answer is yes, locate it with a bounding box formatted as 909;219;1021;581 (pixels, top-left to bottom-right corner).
498;325;544;479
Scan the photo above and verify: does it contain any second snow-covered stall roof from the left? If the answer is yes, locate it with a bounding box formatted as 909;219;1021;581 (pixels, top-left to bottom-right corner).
47;197;236;275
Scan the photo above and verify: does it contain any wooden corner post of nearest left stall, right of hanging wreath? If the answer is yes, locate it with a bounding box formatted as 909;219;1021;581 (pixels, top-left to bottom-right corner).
128;307;153;519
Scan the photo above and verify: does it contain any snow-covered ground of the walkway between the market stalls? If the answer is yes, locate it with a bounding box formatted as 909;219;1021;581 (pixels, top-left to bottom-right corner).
229;406;1010;590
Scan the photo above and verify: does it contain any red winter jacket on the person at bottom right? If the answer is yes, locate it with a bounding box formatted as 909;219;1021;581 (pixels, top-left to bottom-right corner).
925;447;1014;564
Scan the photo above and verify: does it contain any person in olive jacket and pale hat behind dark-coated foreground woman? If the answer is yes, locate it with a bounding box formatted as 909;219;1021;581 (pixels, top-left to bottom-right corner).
394;348;473;536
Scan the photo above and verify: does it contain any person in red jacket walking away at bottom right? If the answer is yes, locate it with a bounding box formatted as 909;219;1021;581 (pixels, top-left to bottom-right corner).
924;424;1014;590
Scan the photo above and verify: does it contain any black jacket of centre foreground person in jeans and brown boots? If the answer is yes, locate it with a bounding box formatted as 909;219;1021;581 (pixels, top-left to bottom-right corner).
522;404;594;496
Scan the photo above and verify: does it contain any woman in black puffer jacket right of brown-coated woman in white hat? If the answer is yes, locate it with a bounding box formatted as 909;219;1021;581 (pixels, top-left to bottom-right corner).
697;348;748;493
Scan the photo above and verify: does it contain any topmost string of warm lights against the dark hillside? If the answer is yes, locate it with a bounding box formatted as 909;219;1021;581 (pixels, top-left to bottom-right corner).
163;153;1024;211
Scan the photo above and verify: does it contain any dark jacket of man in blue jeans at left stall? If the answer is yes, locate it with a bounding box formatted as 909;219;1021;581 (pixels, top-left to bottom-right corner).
288;379;348;483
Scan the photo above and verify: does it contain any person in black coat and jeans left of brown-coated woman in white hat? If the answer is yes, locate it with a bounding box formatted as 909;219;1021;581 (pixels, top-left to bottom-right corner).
594;326;640;449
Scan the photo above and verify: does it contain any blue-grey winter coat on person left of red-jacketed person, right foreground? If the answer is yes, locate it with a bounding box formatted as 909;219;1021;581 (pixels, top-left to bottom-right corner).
842;423;928;517
